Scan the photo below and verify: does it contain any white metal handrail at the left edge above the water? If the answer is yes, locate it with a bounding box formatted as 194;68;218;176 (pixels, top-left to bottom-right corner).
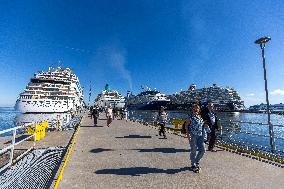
0;122;37;173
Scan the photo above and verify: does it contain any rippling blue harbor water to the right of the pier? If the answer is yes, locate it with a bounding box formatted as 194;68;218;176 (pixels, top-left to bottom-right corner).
129;110;284;154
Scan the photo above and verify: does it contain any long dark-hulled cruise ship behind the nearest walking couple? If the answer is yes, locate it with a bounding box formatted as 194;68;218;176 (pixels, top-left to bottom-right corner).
169;84;245;111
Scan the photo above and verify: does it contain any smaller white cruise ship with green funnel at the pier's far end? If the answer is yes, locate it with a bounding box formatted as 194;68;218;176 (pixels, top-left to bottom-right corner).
95;84;125;109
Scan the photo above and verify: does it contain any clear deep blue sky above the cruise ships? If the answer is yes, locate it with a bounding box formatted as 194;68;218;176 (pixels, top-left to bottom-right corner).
0;0;284;106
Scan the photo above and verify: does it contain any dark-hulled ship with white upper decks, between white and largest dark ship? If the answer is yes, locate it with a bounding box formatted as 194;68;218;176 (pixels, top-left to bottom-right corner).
127;87;170;110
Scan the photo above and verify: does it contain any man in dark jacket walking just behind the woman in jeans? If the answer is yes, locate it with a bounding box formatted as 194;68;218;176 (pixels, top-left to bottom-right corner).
202;101;219;152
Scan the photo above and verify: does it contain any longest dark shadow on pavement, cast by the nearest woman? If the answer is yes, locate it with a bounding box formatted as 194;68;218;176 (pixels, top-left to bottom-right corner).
95;167;190;176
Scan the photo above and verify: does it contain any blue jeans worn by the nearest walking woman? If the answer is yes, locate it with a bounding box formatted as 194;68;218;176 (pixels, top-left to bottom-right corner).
190;135;205;166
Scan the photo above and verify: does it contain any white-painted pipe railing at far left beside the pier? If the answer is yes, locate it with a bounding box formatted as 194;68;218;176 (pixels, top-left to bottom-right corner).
0;122;36;173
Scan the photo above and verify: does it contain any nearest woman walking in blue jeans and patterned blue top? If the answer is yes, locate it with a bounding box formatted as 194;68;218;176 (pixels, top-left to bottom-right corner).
185;103;208;173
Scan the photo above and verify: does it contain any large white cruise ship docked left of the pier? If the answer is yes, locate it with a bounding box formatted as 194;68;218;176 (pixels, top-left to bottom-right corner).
15;67;84;113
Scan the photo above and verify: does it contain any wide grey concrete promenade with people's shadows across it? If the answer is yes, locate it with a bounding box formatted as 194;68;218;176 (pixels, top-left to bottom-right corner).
59;116;284;189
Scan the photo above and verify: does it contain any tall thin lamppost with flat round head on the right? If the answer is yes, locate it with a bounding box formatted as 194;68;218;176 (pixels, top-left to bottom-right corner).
255;37;276;152
